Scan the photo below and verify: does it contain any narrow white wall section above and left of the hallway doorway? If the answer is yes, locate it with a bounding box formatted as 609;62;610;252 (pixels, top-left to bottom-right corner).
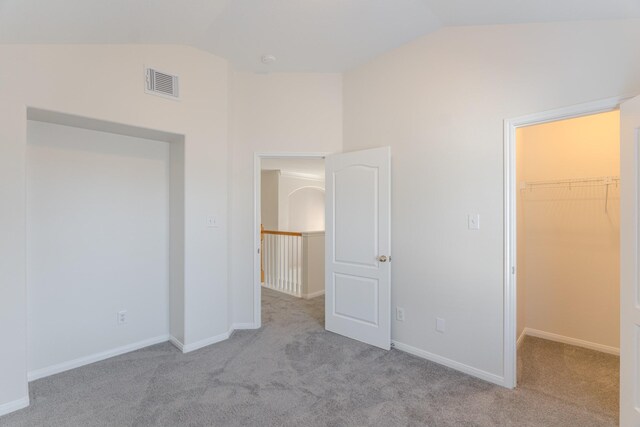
229;72;342;324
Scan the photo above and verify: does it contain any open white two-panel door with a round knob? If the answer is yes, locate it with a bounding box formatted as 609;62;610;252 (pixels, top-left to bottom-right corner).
325;147;391;350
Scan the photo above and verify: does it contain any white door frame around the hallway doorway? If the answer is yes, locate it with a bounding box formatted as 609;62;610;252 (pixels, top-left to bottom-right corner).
253;151;331;328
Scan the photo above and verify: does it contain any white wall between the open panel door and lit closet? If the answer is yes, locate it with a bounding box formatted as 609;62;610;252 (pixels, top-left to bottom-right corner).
344;20;640;382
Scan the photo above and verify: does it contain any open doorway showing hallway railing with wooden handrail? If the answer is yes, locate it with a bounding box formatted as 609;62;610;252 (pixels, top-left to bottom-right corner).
256;154;325;328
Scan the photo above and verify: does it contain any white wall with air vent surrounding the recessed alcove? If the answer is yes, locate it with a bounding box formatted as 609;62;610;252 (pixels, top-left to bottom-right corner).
0;45;229;408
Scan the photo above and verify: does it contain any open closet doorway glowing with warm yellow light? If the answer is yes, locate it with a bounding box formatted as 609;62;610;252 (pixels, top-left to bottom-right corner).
514;110;620;420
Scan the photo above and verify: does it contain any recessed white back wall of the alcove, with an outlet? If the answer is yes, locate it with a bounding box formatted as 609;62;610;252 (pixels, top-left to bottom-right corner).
27;121;169;372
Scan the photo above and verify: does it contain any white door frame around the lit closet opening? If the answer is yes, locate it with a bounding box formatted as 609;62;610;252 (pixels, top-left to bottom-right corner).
503;97;628;388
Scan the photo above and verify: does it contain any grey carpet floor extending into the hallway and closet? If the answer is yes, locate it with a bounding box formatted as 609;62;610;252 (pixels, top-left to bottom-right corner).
0;290;618;427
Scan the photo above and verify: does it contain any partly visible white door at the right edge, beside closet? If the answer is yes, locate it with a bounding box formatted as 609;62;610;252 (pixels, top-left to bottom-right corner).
620;97;640;427
